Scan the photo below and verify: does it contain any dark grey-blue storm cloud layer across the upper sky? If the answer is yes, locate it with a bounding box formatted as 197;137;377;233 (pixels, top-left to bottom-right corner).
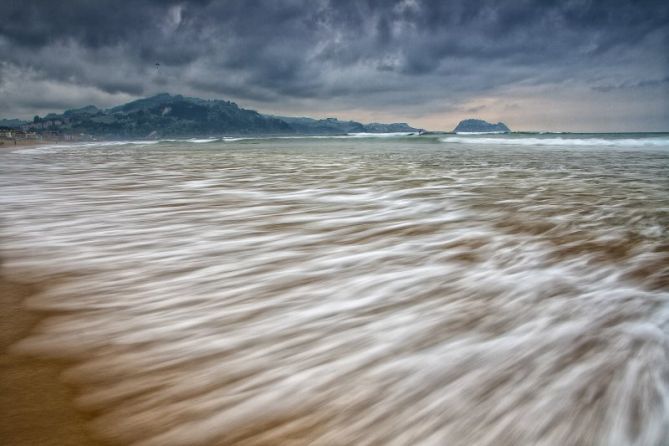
0;0;669;129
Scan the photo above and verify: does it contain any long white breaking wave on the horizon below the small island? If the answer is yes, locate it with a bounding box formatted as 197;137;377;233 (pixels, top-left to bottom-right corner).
440;136;669;147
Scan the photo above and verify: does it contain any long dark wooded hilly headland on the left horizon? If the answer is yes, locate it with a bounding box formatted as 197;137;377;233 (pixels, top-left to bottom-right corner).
0;93;420;139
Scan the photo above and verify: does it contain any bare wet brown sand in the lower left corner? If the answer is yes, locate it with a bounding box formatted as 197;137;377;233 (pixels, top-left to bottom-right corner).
0;270;102;446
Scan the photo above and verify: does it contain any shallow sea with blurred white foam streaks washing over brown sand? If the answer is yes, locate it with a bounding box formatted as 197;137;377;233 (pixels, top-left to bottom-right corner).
0;138;669;446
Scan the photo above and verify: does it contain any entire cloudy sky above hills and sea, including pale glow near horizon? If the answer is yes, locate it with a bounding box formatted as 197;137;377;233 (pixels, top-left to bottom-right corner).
0;0;669;132
